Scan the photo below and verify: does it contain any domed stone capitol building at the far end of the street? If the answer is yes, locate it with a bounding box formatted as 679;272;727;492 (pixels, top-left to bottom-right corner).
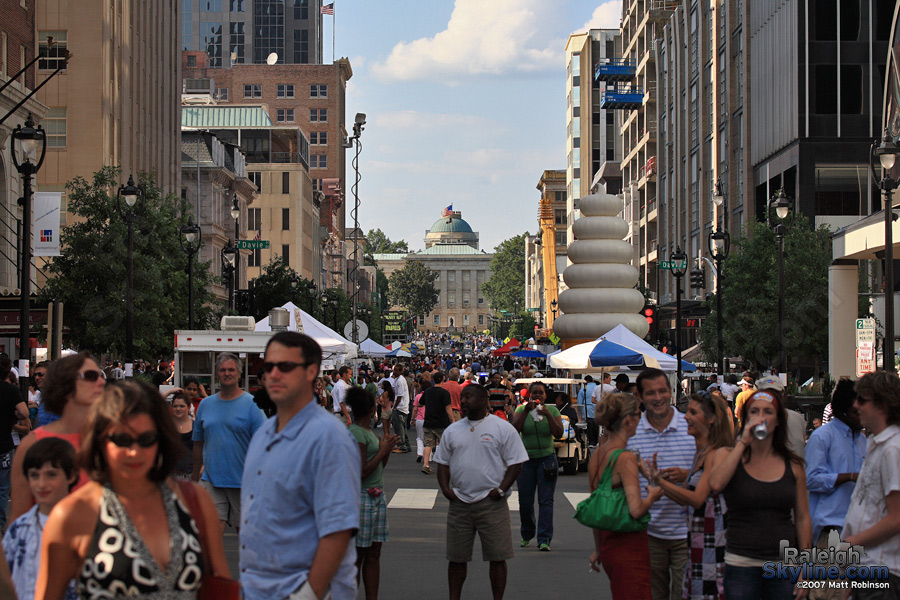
373;211;494;331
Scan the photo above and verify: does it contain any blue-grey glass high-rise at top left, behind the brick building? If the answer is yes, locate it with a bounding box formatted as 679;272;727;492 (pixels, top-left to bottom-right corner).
180;0;322;67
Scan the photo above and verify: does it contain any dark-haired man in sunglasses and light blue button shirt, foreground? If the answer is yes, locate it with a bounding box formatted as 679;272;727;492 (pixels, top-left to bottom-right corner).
244;331;362;600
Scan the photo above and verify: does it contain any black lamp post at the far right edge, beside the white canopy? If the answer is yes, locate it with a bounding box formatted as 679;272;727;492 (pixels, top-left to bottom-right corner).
870;129;900;372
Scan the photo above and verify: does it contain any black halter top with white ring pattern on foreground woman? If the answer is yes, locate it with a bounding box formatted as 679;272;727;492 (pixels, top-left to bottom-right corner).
76;485;203;600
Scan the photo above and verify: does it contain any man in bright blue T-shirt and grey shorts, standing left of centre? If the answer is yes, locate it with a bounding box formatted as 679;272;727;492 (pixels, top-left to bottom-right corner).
192;352;266;534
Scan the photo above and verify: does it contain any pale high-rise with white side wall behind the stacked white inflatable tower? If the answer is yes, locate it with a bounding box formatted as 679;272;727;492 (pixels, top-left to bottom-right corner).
566;29;622;252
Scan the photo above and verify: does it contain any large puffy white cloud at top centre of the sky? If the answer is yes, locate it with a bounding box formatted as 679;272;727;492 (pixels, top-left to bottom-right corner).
373;0;565;84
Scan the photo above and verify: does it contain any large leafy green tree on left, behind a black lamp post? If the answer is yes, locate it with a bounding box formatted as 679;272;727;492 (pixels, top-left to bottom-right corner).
42;167;222;358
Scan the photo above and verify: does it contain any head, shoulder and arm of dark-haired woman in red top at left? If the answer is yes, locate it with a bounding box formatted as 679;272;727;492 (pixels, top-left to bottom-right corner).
9;352;106;521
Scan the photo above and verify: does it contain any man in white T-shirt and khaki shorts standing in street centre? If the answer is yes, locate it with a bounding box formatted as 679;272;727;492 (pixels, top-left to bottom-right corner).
434;384;528;600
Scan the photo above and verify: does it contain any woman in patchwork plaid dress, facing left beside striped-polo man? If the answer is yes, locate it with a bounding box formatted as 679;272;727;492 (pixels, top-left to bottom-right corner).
641;391;734;600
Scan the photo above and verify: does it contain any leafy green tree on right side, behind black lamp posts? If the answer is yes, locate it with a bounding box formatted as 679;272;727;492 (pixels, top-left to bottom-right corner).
701;215;831;367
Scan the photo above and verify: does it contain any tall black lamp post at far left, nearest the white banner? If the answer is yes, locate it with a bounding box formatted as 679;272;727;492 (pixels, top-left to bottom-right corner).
12;113;47;398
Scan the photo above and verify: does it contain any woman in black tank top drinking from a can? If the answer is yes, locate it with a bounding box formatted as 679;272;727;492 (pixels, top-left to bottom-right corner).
709;389;812;600
